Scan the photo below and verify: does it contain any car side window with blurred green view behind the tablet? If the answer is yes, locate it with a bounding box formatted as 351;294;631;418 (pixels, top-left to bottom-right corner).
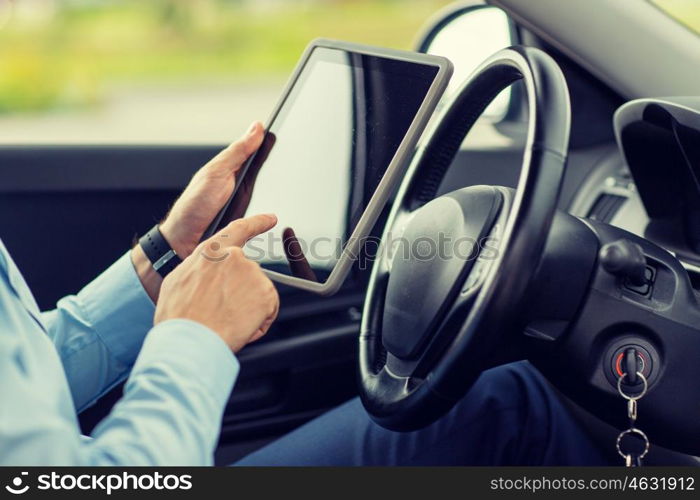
0;0;449;144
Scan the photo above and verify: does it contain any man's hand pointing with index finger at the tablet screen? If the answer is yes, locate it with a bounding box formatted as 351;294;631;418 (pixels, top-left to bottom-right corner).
154;215;279;352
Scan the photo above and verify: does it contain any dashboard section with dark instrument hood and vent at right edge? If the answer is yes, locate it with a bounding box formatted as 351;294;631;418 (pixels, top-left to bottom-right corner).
570;97;700;288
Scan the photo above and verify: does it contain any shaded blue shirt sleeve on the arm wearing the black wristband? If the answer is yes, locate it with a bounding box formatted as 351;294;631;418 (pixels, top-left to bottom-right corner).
42;252;155;411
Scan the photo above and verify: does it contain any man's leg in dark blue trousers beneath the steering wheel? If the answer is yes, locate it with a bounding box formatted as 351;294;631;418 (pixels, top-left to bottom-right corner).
236;362;606;465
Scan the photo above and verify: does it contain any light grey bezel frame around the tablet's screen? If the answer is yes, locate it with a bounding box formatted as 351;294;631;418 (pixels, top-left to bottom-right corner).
204;38;452;295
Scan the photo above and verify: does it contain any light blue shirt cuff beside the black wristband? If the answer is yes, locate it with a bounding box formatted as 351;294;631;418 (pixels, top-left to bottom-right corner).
78;251;155;366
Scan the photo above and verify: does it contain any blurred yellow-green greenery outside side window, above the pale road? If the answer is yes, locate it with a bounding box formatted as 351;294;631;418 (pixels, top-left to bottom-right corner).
0;0;449;114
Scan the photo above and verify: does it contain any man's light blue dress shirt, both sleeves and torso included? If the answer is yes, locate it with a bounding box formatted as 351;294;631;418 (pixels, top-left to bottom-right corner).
0;241;239;466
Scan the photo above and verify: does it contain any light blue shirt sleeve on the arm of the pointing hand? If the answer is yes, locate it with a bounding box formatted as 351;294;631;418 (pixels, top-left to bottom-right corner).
86;319;239;464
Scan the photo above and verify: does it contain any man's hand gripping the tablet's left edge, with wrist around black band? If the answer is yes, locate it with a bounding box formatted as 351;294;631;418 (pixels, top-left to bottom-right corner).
131;122;265;301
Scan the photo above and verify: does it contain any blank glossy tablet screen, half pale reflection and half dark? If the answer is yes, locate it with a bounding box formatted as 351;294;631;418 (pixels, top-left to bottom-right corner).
208;47;439;283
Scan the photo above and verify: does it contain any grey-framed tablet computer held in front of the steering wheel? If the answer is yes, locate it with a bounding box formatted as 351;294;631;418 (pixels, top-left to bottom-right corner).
204;39;452;294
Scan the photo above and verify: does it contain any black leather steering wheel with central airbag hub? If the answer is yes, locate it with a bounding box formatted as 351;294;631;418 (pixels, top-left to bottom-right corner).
359;46;570;431
